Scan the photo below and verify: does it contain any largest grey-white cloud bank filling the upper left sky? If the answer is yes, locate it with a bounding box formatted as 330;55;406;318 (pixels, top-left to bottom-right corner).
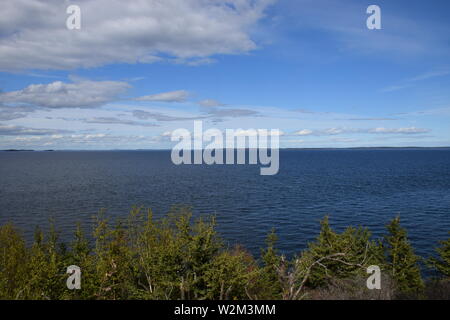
0;0;273;71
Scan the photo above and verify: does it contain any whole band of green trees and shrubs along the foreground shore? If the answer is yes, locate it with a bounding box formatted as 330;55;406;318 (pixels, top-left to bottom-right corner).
0;207;450;300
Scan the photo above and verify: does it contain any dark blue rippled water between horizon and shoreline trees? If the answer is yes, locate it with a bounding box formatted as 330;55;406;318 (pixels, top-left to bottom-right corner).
0;149;450;257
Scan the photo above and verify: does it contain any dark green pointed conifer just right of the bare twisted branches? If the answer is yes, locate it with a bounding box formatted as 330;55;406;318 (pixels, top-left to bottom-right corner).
382;217;424;297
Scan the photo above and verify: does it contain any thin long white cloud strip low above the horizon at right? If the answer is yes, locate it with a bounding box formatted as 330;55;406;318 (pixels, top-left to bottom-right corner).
294;127;430;136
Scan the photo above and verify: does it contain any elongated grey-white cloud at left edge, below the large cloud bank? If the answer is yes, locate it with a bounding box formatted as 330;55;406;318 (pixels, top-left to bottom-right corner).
0;80;130;108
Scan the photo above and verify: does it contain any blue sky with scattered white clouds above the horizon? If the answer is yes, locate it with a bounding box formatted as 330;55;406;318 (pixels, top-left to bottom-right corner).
0;0;450;150
